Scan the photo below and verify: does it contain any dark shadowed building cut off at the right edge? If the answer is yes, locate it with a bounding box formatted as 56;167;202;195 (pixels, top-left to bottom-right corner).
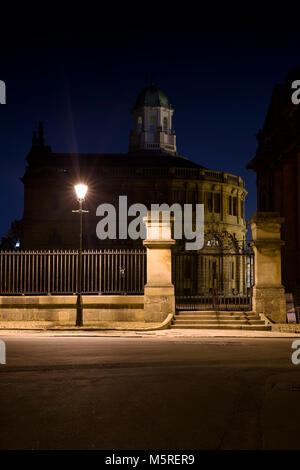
247;68;300;305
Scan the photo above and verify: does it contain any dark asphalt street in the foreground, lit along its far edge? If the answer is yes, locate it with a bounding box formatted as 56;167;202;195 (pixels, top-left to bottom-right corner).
0;333;300;450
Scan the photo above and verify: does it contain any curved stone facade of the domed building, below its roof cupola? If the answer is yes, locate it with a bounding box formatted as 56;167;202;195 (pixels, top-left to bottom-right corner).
21;147;247;253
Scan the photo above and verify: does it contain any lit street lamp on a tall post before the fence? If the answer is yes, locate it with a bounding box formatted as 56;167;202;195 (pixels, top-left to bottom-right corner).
72;183;88;326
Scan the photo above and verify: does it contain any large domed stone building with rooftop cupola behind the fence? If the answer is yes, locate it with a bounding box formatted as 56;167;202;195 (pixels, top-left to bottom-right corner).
21;83;247;291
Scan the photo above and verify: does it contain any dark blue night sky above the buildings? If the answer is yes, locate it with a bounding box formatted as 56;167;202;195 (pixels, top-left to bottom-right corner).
0;8;300;237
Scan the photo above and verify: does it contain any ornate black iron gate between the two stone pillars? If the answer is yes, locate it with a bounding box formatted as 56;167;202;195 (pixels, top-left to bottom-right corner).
173;249;254;310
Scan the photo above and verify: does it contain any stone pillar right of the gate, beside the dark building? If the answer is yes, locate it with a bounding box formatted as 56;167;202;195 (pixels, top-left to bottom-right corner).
249;212;286;323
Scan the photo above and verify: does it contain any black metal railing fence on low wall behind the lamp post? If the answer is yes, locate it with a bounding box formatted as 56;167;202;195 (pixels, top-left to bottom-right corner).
0;250;146;295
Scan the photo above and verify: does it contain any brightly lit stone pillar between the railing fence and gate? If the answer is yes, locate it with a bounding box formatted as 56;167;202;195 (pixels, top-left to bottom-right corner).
143;212;176;322
